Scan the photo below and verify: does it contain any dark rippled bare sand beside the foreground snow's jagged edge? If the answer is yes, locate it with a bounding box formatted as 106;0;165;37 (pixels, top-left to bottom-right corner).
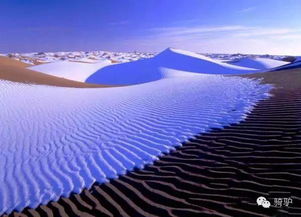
2;69;301;216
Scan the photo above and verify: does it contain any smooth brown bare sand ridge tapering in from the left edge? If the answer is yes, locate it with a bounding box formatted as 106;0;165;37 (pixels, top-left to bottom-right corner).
0;57;110;88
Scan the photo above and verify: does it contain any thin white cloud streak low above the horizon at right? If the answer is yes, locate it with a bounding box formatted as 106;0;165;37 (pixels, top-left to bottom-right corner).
123;25;301;55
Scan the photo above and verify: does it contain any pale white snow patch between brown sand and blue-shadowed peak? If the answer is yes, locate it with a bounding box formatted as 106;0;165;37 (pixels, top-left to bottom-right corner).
29;60;111;82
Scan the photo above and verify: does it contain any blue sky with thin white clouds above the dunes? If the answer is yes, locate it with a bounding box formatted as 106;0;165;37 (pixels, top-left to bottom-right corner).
0;0;301;55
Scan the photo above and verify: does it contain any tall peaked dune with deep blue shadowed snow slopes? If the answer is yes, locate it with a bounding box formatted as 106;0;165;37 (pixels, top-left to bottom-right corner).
86;48;255;85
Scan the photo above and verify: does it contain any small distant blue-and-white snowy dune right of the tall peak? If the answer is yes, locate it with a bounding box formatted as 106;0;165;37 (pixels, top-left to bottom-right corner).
229;57;288;70
